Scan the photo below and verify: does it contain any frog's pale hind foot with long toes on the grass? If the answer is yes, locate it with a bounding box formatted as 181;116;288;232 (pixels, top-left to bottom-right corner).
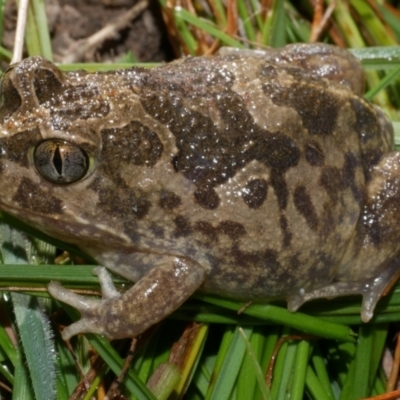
288;261;400;322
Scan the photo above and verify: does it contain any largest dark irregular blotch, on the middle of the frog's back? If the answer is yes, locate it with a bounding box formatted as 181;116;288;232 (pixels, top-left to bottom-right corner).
140;60;300;210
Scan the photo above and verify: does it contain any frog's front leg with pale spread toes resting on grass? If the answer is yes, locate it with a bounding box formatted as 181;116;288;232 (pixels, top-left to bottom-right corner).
48;257;205;340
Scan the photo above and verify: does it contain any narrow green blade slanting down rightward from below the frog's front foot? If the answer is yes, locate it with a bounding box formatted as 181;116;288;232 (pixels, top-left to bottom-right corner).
87;334;156;400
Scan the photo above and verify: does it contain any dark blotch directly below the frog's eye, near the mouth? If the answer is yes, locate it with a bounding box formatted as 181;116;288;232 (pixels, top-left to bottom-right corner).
13;178;63;215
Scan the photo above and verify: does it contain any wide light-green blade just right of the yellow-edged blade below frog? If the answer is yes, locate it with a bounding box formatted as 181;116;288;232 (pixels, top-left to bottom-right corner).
206;327;252;400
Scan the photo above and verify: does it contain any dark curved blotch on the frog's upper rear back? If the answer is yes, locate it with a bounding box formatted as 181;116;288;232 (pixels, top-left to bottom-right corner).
263;82;340;136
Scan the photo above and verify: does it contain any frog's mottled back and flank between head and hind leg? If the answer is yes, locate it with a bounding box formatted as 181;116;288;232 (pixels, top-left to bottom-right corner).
110;51;393;299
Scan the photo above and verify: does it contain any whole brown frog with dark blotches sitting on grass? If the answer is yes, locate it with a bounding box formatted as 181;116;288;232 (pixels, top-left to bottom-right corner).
0;44;400;340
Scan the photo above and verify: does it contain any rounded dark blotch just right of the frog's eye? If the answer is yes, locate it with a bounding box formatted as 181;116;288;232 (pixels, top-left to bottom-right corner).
101;121;163;176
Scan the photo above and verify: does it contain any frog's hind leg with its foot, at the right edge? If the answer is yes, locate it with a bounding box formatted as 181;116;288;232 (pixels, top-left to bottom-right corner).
288;152;400;321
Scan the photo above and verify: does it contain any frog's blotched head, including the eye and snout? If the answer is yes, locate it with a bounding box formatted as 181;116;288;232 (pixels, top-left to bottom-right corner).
0;57;138;250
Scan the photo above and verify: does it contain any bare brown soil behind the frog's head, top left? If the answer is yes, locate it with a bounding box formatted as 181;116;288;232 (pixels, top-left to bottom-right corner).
3;0;172;62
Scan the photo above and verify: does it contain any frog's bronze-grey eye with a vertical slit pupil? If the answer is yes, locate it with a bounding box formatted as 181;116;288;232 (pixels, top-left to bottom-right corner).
33;139;89;184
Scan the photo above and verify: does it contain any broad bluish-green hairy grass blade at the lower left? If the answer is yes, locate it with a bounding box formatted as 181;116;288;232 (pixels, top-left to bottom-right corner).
0;224;56;399
